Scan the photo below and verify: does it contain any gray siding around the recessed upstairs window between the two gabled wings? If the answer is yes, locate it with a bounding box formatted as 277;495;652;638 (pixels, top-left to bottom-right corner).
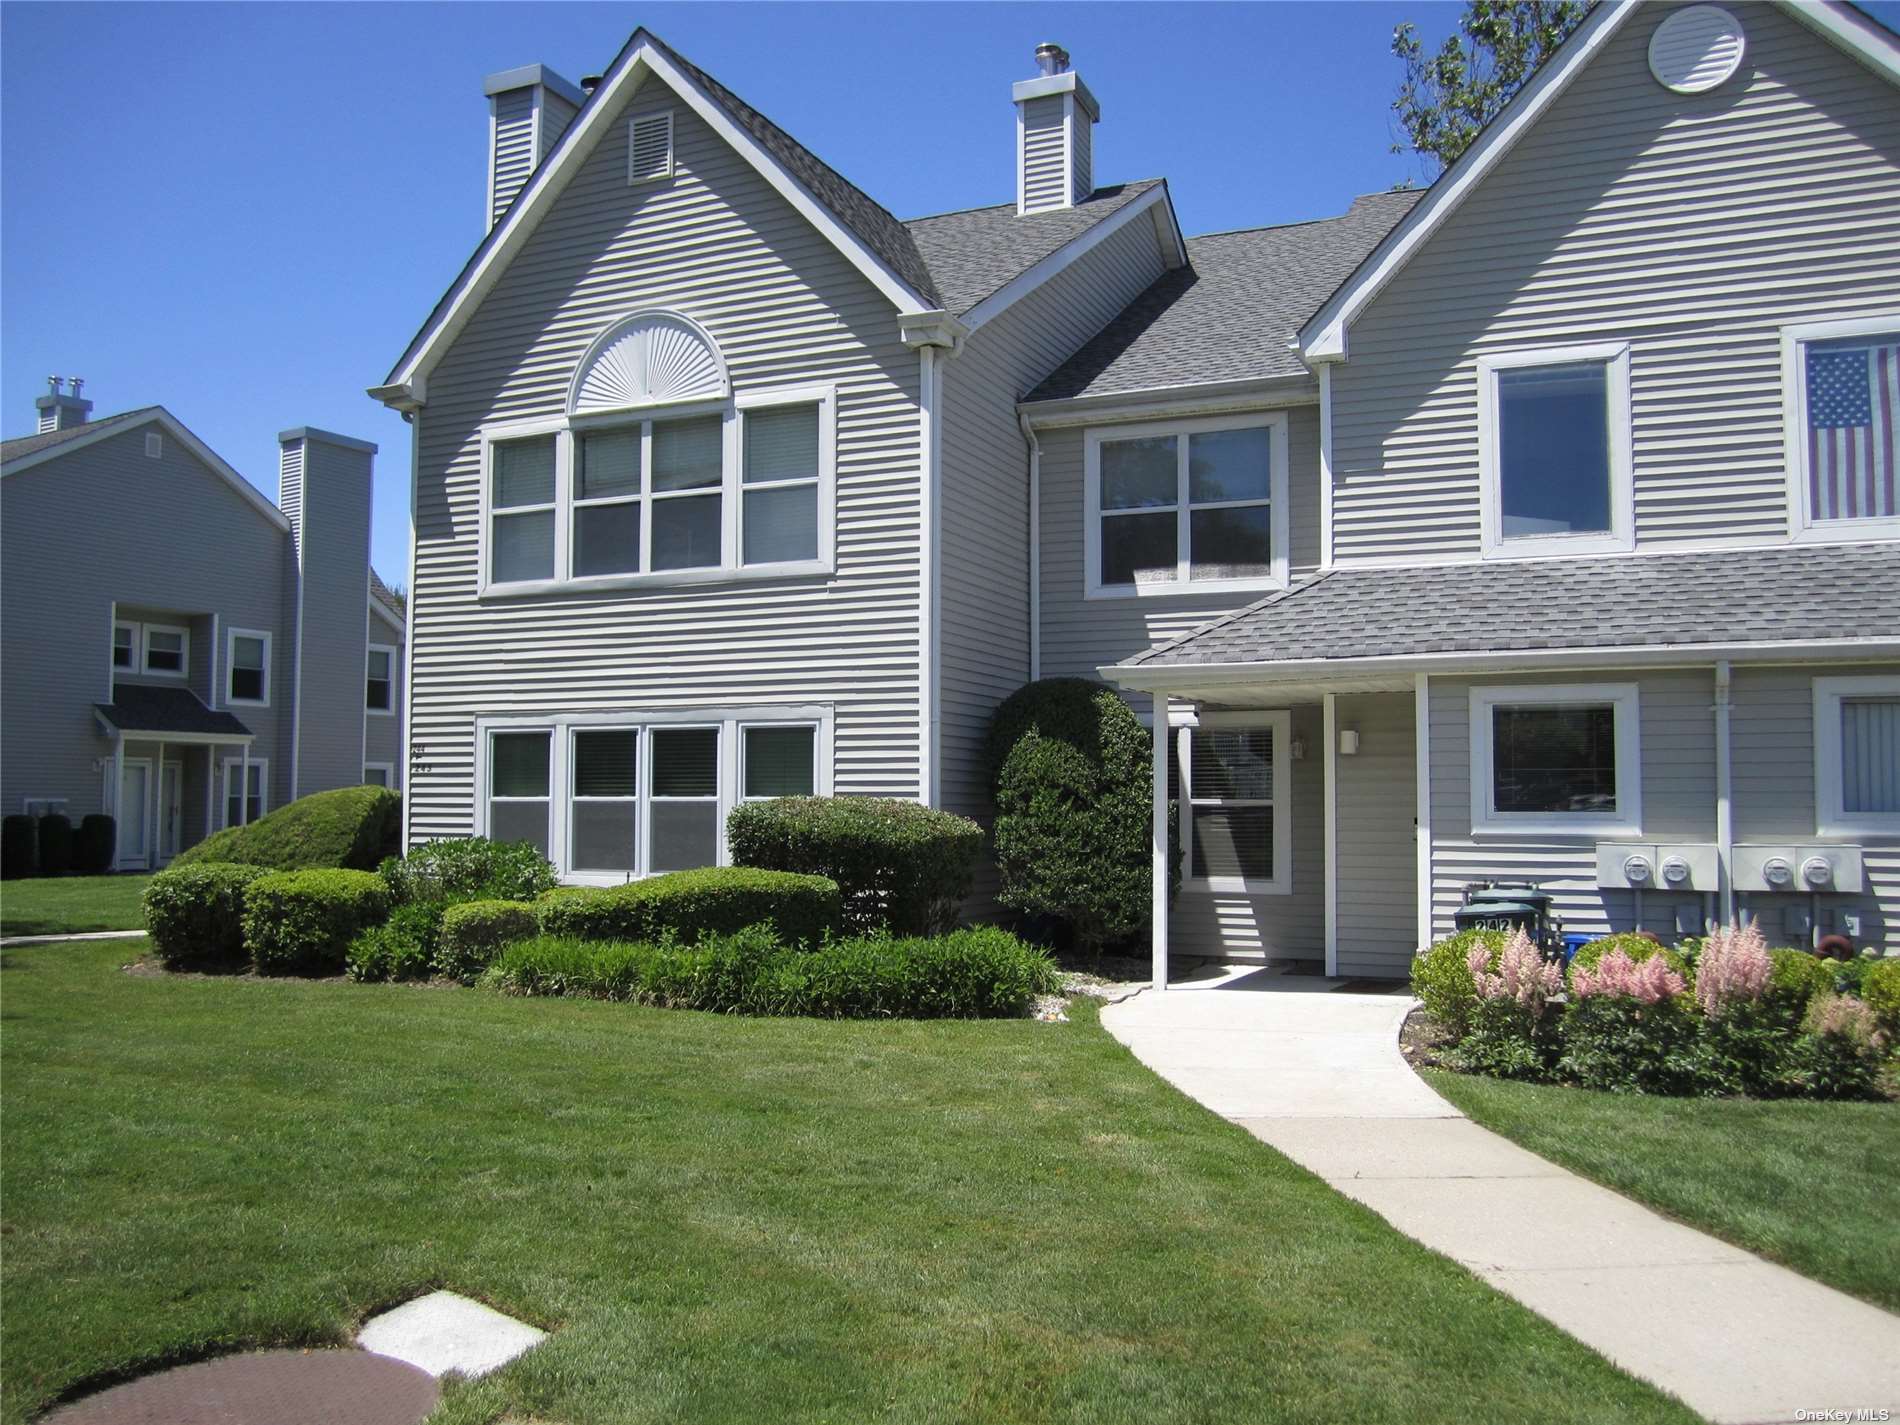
1041;405;1319;676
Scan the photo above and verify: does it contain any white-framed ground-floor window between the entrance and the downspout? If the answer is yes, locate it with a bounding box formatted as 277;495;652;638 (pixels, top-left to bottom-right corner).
1471;684;1642;836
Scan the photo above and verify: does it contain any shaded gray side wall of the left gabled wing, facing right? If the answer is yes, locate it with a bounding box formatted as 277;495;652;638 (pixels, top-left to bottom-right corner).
939;209;1163;817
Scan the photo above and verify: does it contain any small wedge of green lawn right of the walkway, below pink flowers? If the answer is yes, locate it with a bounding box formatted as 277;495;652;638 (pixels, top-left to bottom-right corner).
1425;1070;1900;1311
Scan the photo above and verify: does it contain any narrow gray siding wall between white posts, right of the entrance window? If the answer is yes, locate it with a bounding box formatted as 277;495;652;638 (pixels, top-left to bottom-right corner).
1330;694;1417;979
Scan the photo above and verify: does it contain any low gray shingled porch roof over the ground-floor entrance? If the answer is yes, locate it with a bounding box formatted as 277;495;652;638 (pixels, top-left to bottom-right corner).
1127;543;1900;667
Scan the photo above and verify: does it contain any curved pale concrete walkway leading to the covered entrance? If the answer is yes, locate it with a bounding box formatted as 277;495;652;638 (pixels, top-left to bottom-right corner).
1102;971;1900;1425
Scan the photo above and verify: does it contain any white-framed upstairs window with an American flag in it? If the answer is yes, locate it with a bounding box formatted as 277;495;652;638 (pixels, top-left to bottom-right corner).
1782;314;1900;540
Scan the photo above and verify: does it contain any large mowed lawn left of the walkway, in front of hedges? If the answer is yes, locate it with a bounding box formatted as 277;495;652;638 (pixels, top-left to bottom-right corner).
0;944;1693;1425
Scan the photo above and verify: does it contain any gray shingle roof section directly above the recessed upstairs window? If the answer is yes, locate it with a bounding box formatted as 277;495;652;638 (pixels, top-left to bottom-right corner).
1024;190;1421;401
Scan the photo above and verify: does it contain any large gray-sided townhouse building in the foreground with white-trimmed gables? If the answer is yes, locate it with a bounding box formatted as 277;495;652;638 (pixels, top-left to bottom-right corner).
372;4;1900;975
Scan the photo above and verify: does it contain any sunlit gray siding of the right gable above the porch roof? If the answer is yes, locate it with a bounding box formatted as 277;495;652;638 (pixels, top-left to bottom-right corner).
1332;6;1900;562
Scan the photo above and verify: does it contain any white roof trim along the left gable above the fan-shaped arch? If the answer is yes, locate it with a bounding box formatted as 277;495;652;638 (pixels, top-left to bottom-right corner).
371;34;931;407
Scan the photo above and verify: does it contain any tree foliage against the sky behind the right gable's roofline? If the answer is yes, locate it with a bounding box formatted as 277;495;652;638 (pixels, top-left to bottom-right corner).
1393;0;1596;175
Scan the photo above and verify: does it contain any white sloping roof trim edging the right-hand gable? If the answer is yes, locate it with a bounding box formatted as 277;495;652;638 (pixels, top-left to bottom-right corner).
1300;0;1900;363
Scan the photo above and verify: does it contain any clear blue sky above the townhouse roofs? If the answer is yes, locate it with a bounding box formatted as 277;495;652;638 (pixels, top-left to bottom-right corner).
0;0;1900;581
